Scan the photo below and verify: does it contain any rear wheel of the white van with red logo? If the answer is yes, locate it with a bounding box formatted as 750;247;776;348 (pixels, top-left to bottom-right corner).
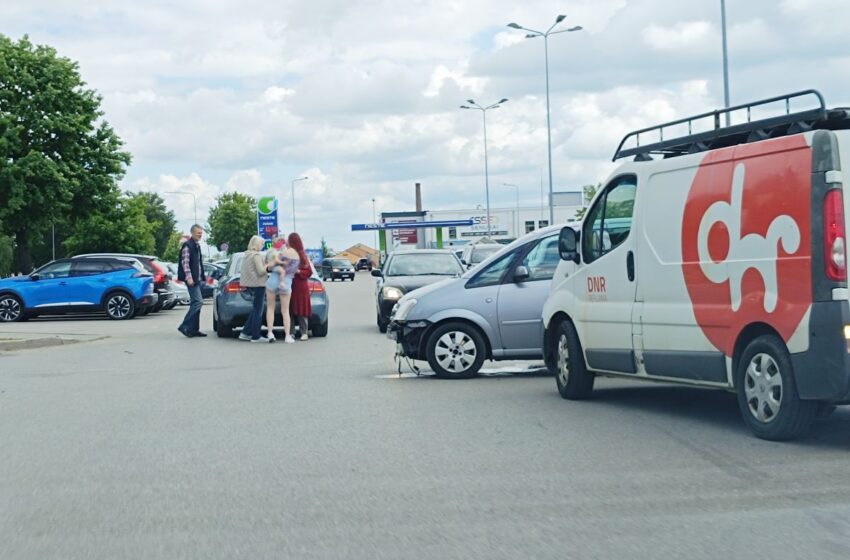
735;335;818;441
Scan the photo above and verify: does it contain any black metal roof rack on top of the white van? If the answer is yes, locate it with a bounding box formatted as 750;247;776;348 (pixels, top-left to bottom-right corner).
611;89;850;161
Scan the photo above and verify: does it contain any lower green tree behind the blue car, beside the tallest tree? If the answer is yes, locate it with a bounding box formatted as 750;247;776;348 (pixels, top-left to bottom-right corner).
63;195;156;255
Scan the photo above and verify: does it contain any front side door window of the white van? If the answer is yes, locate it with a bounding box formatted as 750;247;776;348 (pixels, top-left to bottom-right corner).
581;175;637;263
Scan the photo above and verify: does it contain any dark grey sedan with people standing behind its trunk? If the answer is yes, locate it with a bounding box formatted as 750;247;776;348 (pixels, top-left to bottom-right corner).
213;253;330;338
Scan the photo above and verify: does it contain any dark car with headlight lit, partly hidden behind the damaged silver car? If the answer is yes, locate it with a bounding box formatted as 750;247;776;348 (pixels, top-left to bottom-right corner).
372;249;463;332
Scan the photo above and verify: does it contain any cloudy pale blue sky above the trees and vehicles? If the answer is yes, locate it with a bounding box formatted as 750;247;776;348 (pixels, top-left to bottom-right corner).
0;0;850;249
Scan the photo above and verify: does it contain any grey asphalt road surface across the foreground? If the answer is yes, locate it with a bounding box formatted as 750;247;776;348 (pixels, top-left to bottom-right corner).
0;273;850;560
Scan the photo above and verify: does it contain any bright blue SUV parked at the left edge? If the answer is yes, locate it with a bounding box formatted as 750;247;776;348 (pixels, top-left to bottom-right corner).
0;257;158;323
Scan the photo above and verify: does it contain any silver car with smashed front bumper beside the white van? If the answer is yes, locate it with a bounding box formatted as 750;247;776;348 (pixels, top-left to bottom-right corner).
387;225;562;378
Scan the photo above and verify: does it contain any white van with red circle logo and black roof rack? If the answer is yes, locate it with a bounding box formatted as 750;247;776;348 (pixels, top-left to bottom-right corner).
543;90;850;440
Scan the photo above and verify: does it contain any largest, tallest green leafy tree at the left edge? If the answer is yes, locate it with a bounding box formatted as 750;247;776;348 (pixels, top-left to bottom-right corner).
0;35;130;272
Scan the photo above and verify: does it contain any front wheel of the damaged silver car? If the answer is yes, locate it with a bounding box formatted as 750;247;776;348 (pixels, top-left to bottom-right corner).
426;323;487;379
